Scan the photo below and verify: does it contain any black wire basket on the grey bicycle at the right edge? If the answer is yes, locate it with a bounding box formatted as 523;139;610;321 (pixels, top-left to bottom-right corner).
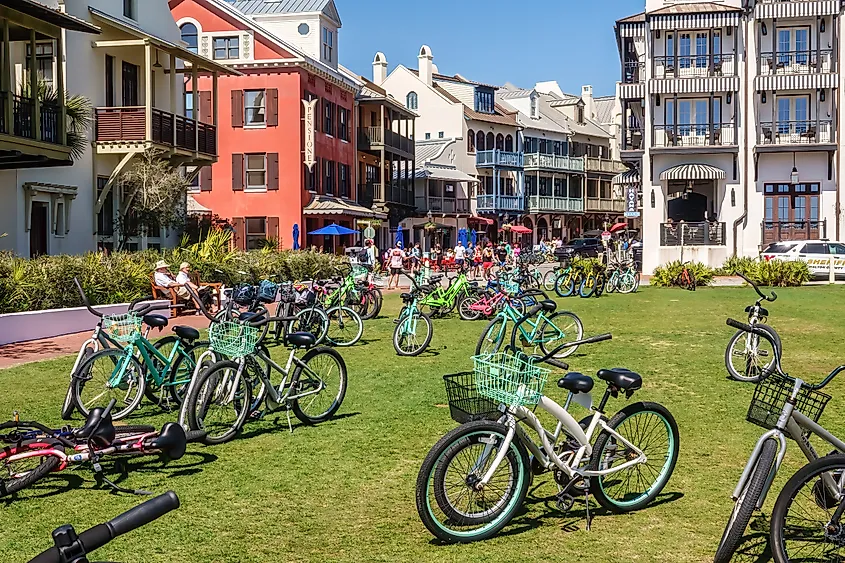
746;374;830;436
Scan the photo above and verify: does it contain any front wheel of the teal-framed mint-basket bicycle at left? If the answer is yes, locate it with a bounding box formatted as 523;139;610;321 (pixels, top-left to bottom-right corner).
73;348;146;420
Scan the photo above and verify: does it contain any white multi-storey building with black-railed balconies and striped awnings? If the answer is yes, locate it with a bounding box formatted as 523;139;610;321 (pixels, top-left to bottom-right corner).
616;0;843;271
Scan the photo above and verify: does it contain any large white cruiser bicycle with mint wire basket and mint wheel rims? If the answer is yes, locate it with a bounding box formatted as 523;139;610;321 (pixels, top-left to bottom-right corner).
415;301;679;543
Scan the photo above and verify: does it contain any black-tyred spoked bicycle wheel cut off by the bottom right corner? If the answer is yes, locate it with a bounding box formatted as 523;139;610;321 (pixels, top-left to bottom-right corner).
769;455;845;563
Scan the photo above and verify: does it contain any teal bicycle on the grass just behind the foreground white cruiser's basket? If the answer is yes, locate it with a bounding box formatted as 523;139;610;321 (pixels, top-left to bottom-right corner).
475;302;584;358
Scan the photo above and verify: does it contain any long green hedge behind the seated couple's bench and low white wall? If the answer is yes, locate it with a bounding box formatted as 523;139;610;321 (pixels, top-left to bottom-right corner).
0;233;347;313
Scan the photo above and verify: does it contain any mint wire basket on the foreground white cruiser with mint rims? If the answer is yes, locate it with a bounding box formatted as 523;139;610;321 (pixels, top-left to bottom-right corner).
472;352;551;406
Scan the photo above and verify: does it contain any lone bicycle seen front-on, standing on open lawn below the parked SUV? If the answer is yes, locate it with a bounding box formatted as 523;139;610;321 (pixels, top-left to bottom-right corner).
725;272;781;383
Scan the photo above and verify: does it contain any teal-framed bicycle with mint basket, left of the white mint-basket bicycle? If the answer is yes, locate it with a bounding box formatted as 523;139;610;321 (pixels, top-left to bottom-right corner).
72;279;207;420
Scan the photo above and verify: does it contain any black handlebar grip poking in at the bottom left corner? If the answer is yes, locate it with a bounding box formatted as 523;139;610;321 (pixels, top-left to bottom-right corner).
29;491;179;563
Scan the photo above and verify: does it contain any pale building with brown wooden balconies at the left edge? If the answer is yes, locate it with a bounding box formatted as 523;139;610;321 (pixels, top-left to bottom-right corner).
0;0;228;256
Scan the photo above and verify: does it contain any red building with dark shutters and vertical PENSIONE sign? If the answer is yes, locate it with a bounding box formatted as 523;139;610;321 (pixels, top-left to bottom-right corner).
170;0;374;249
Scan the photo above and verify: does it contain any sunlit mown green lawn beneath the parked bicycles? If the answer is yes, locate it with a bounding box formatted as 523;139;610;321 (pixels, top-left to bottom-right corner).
0;287;845;563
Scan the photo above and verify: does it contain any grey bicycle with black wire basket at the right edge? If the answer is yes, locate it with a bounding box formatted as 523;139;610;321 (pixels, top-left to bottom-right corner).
714;319;845;563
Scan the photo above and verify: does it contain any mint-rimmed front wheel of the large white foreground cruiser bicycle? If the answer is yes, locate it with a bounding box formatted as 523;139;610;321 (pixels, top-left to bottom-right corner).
416;421;531;543
